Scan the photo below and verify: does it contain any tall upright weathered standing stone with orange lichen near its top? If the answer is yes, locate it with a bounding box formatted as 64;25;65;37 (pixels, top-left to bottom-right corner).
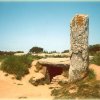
69;14;89;82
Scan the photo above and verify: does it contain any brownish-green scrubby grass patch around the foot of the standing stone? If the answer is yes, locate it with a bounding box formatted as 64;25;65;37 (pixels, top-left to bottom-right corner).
51;70;100;99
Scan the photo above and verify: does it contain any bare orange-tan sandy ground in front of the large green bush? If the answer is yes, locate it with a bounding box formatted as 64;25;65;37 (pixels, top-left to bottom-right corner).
0;61;53;100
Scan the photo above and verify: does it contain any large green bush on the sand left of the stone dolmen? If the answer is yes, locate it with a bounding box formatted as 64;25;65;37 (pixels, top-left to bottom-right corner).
1;55;40;80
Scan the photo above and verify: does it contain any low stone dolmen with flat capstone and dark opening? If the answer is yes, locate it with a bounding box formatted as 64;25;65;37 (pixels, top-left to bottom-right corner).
29;58;70;85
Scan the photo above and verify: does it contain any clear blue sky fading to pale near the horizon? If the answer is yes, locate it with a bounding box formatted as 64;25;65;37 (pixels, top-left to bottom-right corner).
0;2;100;52
